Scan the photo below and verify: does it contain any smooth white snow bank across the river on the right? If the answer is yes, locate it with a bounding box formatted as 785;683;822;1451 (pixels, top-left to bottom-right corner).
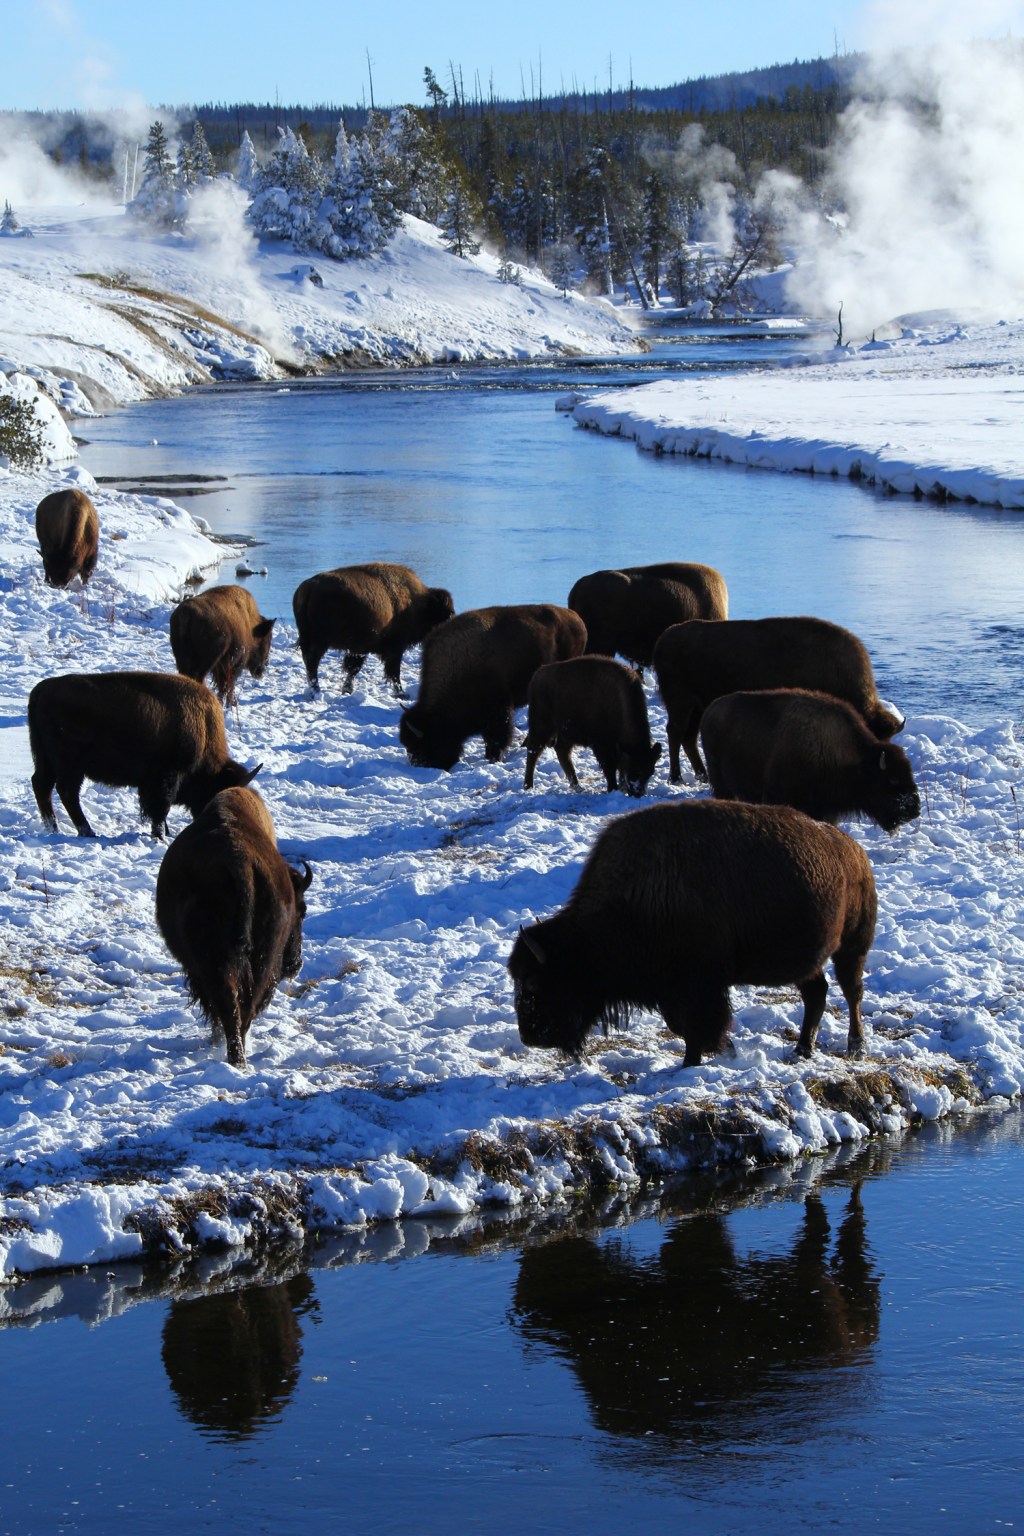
571;316;1024;508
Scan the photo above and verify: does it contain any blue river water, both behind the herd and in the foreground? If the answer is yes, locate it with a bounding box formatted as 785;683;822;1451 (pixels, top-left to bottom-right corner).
0;330;1024;1536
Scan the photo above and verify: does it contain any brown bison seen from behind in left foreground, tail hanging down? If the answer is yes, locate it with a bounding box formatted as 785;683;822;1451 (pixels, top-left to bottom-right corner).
157;788;313;1068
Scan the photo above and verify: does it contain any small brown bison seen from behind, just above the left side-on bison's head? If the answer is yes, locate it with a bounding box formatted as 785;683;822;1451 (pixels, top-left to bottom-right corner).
170;585;276;703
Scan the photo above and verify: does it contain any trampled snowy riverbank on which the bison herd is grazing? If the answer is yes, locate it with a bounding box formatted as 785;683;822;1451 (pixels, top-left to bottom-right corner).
0;448;1024;1273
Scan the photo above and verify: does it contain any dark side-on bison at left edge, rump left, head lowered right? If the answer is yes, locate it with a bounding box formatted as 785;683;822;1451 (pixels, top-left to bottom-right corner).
29;673;259;837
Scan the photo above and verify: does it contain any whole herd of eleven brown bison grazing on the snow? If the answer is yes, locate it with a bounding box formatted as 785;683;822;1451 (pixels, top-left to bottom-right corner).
28;492;921;1068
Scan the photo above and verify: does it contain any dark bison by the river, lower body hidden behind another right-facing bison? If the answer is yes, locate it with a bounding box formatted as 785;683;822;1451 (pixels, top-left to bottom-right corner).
654;617;906;783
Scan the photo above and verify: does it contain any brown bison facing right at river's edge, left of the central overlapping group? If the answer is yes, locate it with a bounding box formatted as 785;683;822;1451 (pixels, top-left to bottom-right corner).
292;562;454;696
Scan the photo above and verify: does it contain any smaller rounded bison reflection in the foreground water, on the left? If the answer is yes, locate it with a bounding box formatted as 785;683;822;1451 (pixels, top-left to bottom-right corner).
161;1275;316;1439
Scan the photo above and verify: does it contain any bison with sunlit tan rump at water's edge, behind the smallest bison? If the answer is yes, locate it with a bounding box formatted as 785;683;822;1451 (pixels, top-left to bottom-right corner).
570;561;729;671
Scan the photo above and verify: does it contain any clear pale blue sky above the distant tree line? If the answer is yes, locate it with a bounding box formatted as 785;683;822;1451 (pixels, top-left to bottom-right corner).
0;0;867;109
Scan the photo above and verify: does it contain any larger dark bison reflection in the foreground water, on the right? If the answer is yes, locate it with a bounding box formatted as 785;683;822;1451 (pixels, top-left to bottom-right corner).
514;1187;881;1445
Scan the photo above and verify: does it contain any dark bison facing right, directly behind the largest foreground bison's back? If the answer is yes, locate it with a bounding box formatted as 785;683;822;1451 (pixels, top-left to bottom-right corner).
700;688;921;833
